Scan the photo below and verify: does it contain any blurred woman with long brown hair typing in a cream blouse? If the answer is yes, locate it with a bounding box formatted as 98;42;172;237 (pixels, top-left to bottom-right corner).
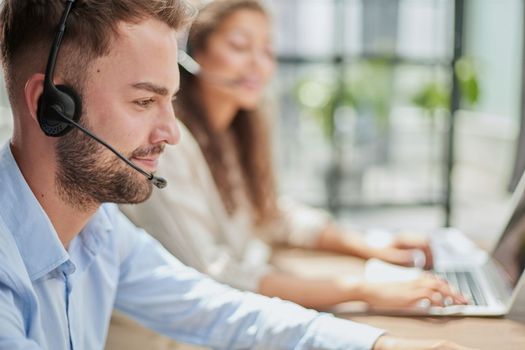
124;0;465;309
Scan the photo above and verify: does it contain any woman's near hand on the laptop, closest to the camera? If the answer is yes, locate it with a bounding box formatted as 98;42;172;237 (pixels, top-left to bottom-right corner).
362;274;468;308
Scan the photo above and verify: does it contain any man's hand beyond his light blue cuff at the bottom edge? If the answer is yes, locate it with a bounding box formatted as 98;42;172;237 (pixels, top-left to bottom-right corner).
373;335;473;350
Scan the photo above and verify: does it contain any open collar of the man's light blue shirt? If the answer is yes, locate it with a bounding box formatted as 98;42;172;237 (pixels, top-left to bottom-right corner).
0;142;112;281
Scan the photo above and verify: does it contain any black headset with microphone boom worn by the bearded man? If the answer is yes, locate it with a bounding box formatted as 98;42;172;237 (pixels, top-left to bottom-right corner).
37;0;168;188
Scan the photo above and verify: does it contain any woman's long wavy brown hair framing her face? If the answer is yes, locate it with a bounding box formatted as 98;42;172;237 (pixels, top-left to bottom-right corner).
175;0;276;225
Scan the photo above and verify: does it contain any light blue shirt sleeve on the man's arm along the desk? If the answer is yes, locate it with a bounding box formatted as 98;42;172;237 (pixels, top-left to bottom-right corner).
110;206;382;350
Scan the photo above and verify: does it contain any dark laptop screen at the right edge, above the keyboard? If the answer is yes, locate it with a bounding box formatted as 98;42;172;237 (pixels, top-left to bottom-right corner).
492;181;525;287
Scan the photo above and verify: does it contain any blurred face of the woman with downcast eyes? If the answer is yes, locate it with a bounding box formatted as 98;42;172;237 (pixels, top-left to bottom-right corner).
195;9;275;110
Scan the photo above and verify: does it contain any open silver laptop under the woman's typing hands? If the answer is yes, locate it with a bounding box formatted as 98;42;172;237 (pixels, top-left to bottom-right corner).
331;174;525;316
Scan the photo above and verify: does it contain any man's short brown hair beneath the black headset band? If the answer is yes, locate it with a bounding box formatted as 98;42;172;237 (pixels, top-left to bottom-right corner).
0;0;195;109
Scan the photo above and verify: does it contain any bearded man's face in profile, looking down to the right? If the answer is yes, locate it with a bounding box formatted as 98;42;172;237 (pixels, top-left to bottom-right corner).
57;19;179;209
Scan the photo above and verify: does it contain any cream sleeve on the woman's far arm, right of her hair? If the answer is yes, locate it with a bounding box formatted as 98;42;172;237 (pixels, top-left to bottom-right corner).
262;197;332;248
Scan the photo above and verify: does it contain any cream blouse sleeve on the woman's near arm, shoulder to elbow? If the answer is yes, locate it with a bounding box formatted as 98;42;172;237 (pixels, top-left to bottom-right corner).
121;129;272;291
